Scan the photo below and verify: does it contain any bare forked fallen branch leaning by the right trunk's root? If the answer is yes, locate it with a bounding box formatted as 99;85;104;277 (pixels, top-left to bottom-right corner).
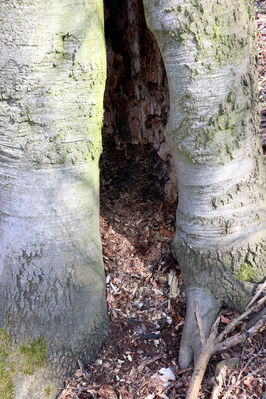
186;290;266;399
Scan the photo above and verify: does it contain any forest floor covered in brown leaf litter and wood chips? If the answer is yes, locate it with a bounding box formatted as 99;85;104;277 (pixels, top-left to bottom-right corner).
60;1;266;399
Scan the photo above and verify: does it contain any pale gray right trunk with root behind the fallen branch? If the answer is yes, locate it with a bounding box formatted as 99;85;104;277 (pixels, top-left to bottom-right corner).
144;0;265;367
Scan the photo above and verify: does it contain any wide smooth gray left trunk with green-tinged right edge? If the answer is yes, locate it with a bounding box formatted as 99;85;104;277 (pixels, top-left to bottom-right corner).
0;0;108;399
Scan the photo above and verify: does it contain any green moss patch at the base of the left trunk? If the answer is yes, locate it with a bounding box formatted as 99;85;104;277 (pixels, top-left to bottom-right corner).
0;329;46;399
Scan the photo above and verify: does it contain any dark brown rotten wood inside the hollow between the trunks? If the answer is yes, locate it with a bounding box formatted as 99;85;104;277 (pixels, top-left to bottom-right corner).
103;0;177;203
